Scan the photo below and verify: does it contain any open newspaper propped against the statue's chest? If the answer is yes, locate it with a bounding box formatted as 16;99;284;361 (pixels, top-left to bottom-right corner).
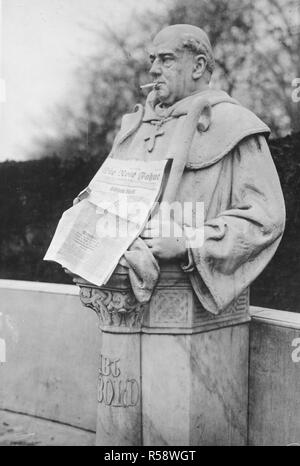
44;158;168;286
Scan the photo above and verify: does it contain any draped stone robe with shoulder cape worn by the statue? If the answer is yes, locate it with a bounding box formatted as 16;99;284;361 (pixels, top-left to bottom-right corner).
110;90;285;314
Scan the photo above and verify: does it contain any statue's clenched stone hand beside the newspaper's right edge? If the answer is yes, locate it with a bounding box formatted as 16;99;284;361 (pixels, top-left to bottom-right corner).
141;219;187;261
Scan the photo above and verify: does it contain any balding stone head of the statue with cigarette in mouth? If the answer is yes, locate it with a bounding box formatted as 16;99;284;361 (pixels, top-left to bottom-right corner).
149;24;215;105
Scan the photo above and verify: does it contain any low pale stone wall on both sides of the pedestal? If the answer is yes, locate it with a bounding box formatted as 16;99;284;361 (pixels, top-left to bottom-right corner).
0;280;300;445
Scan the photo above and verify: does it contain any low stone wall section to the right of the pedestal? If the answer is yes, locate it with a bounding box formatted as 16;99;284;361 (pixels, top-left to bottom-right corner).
248;307;300;445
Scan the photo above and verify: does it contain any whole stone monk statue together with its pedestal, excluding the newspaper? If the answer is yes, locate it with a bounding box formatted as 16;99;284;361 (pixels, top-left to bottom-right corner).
72;24;285;445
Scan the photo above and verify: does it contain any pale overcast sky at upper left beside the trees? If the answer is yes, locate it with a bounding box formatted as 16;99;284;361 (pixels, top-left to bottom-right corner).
0;0;161;162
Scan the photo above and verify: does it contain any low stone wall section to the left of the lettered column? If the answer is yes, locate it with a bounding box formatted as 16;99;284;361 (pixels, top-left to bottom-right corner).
0;280;100;430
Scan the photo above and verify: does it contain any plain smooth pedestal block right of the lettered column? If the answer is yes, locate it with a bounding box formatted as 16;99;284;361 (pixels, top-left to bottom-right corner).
142;324;249;446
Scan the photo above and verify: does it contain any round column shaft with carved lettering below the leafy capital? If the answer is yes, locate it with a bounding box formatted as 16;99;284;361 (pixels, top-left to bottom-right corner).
96;332;142;446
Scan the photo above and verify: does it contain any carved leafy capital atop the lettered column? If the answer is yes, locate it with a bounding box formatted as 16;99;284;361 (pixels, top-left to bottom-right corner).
80;286;144;332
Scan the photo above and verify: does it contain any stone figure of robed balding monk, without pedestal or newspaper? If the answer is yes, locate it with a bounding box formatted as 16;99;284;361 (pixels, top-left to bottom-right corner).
75;24;285;314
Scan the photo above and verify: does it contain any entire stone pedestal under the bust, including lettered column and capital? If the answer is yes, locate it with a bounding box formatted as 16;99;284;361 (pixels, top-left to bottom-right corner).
81;264;250;446
